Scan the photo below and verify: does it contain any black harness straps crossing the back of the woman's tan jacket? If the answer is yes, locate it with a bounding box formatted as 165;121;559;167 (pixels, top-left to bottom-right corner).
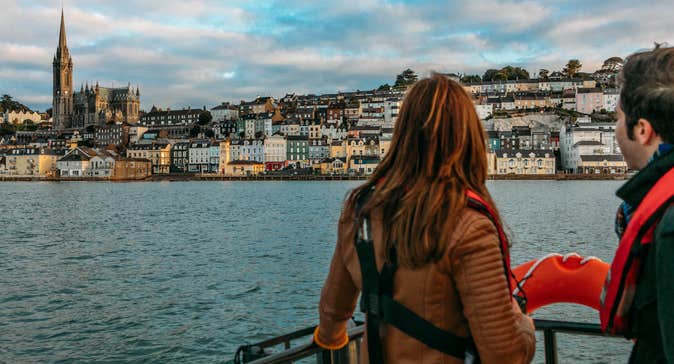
355;192;476;364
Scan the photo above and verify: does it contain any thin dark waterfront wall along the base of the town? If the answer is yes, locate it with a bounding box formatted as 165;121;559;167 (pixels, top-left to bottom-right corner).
0;173;629;182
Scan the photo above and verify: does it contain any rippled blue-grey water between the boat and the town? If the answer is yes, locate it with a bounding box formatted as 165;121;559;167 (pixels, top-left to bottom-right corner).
0;181;630;363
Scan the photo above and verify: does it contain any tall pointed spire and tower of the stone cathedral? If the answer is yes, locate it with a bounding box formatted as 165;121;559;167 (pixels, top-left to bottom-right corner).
52;9;73;130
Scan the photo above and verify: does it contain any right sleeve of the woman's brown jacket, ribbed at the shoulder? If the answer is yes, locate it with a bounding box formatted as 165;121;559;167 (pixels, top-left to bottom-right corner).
448;212;536;364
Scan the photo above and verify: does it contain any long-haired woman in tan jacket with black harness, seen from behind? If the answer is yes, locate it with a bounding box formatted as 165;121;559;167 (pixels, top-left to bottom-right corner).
314;74;535;363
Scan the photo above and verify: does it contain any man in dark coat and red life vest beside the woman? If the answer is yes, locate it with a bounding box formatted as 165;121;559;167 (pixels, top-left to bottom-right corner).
600;46;674;363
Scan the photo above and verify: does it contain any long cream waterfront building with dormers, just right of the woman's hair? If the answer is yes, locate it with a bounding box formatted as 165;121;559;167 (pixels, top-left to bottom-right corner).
494;149;555;175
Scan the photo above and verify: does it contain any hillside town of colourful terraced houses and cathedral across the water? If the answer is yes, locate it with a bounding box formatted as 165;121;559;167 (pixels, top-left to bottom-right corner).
0;9;627;180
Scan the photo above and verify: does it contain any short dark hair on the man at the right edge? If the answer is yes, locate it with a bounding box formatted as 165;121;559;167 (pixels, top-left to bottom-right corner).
619;44;674;143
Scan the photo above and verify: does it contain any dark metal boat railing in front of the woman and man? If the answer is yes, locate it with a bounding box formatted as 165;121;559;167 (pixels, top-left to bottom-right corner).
231;319;617;364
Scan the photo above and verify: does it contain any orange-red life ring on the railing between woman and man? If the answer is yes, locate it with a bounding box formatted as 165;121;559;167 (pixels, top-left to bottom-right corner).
512;253;610;313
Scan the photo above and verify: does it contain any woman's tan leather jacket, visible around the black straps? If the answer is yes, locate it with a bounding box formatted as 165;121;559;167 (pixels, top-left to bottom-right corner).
315;208;536;364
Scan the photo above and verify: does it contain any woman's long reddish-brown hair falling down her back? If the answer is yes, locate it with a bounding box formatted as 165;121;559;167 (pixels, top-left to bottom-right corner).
342;74;494;268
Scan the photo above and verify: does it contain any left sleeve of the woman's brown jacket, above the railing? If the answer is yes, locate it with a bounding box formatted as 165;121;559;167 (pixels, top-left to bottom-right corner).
314;218;360;349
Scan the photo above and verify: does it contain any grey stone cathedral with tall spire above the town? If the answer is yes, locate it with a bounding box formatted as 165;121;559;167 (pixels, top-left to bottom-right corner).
52;11;140;130
